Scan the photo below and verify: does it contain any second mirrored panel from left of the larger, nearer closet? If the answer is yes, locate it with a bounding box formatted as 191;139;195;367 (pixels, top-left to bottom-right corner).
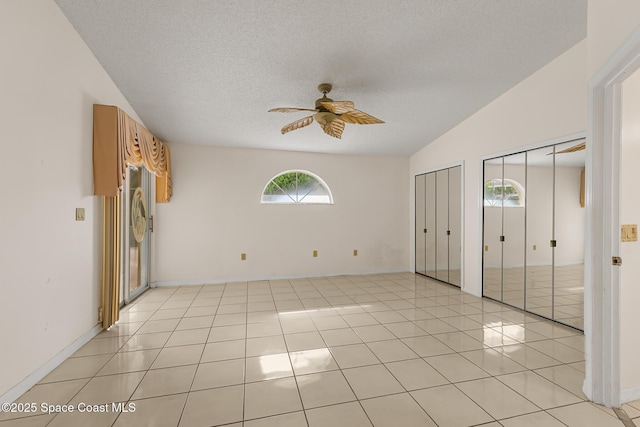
500;153;526;309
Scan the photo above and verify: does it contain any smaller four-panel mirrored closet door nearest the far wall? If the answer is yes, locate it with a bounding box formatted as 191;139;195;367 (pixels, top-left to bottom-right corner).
415;166;462;286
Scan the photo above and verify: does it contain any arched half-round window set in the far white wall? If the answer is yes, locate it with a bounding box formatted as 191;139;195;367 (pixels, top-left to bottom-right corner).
260;170;333;205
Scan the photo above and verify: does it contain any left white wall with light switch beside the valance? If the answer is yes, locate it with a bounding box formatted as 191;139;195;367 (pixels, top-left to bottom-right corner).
0;0;142;396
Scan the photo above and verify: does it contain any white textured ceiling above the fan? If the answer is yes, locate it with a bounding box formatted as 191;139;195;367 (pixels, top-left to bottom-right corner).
56;0;587;156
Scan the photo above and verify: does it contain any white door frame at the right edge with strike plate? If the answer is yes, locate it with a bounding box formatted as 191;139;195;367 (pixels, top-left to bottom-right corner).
583;29;640;407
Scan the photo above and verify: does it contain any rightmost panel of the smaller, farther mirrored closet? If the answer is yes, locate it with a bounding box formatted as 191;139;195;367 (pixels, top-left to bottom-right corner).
449;166;462;287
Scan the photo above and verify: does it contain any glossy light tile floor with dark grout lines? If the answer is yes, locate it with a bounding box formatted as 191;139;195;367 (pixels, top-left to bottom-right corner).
0;273;640;427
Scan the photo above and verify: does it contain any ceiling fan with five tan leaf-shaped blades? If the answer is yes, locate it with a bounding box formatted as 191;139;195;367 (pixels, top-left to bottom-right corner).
269;83;384;138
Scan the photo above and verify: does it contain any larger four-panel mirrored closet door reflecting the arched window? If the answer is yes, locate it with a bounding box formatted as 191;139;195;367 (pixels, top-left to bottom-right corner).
483;140;585;330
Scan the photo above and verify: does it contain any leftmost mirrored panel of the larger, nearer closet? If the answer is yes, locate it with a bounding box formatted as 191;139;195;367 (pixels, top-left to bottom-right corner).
482;157;503;301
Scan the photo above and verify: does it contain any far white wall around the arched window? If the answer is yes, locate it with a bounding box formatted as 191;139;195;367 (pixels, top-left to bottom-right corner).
153;145;409;284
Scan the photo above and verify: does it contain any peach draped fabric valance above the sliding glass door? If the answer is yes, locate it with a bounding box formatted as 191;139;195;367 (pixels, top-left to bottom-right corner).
93;104;172;203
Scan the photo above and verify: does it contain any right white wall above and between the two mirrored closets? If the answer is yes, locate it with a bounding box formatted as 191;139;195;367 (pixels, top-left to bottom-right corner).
409;41;587;295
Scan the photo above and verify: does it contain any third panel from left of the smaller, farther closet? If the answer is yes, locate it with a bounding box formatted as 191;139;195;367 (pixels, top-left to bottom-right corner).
436;169;449;282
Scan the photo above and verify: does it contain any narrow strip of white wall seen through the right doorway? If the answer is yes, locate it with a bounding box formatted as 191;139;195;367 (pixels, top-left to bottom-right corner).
620;70;640;390
